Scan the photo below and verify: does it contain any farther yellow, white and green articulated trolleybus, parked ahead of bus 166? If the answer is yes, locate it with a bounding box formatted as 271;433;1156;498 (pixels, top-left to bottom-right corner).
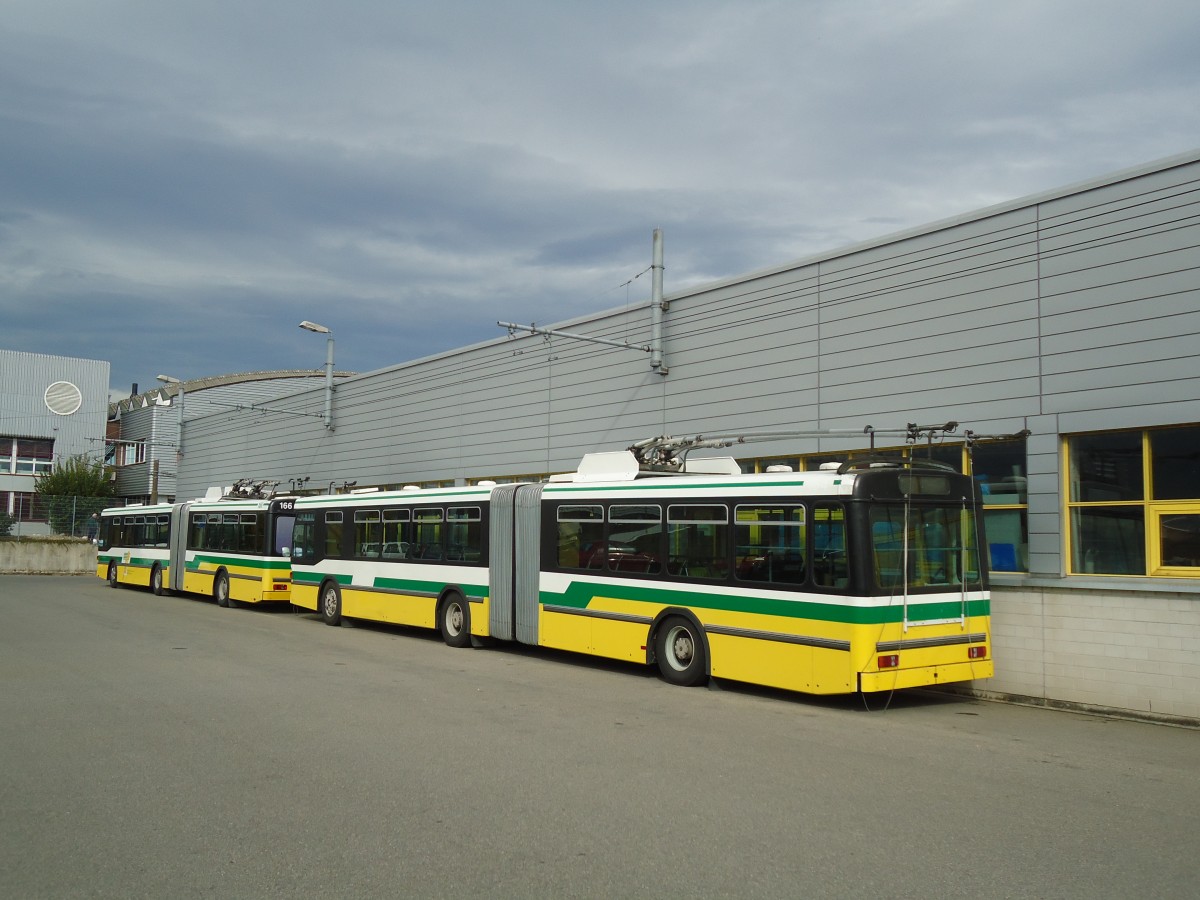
96;481;295;606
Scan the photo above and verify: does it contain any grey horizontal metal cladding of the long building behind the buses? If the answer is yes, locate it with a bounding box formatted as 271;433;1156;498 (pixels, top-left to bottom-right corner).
180;148;1200;585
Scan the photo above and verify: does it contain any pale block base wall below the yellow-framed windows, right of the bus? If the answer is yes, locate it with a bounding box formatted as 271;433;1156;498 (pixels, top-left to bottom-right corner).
974;584;1200;725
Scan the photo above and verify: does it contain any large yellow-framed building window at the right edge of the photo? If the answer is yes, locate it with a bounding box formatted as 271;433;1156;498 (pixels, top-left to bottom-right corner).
1067;425;1200;577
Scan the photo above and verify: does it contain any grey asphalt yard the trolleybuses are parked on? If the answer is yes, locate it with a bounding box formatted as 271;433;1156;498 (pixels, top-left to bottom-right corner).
0;576;1200;900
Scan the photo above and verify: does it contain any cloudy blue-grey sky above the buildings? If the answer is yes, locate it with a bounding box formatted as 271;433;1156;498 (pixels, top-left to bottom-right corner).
0;0;1200;391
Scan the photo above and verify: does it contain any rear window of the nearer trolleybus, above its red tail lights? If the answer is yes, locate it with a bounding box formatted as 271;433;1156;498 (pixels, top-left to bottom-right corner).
871;503;983;593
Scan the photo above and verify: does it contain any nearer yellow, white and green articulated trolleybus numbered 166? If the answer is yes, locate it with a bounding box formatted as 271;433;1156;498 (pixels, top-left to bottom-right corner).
292;434;994;694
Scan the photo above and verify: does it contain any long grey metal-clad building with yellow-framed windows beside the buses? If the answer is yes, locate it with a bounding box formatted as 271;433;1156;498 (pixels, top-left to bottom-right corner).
140;152;1200;721
